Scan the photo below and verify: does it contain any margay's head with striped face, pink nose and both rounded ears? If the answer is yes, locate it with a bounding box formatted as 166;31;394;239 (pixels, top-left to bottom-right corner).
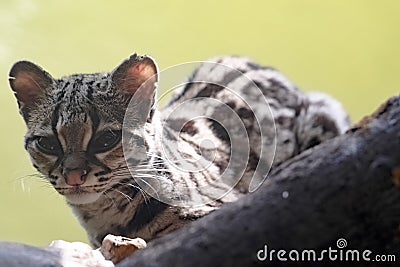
10;54;158;205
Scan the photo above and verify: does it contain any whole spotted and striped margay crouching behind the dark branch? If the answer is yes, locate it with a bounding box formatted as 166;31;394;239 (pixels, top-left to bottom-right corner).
10;54;349;246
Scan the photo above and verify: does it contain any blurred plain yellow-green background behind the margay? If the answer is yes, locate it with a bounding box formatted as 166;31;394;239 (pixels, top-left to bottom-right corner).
0;0;400;246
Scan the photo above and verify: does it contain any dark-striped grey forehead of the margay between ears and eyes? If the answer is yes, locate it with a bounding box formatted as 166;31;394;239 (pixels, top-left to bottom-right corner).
27;73;124;141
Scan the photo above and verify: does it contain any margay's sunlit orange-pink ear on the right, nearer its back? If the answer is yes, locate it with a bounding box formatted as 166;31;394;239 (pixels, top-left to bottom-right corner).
111;54;158;99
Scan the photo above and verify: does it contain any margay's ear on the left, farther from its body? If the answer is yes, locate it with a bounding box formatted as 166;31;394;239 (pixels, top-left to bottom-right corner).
9;61;54;112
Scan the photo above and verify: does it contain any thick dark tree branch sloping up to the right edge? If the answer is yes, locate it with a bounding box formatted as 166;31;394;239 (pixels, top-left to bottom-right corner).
118;97;400;267
